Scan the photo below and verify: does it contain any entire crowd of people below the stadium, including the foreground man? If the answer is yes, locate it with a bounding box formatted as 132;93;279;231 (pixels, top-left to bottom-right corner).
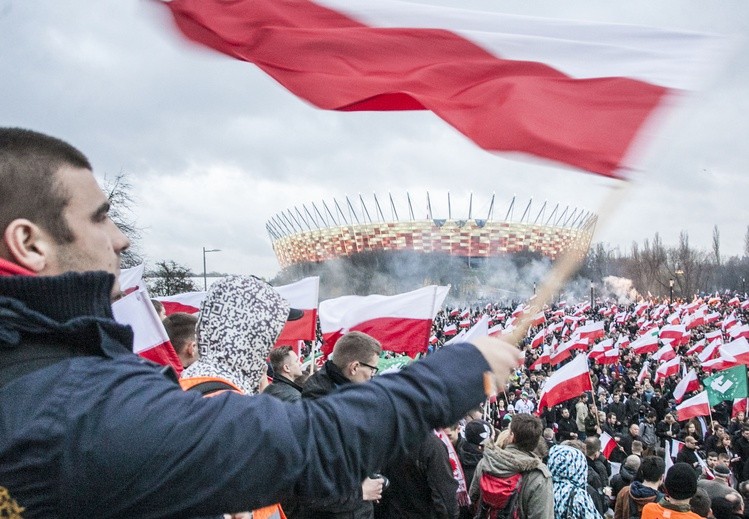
0;129;749;519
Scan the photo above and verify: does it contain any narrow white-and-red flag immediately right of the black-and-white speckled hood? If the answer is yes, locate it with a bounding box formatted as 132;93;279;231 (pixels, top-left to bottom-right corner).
273;276;320;345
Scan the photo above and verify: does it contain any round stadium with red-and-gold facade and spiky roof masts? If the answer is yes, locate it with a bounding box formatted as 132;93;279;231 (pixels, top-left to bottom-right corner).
266;193;597;268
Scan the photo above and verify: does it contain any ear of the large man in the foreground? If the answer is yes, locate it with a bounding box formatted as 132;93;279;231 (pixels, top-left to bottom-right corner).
3;218;55;274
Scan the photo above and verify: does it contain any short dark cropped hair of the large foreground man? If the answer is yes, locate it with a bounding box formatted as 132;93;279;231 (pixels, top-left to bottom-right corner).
0;128;92;244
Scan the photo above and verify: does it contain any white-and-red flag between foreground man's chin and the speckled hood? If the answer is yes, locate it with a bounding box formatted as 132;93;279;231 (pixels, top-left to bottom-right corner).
112;289;182;374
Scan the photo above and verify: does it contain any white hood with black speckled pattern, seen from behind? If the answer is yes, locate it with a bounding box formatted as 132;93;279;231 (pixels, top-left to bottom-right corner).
182;276;289;394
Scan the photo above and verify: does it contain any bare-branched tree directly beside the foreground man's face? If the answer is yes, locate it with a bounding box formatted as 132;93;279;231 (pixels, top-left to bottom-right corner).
103;172;143;268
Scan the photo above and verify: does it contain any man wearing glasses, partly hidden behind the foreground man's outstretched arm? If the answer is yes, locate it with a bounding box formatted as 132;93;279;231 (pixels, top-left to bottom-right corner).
294;332;384;519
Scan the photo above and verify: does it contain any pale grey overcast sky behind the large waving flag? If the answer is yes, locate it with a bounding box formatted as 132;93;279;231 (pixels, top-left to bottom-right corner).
0;0;749;277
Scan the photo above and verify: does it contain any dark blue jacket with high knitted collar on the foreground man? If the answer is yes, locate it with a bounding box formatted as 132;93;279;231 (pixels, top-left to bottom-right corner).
0;273;489;518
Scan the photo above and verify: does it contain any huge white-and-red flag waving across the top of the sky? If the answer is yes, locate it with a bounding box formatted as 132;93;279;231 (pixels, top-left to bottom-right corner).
165;0;725;176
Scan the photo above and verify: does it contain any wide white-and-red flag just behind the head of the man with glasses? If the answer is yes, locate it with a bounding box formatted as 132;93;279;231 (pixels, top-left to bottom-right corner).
319;285;450;357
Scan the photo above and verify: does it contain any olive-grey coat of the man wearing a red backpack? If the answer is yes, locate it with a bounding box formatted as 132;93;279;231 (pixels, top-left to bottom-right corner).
469;443;554;519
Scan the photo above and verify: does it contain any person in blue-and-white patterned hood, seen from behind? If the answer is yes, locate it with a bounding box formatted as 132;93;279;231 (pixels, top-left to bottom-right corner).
548;445;601;519
